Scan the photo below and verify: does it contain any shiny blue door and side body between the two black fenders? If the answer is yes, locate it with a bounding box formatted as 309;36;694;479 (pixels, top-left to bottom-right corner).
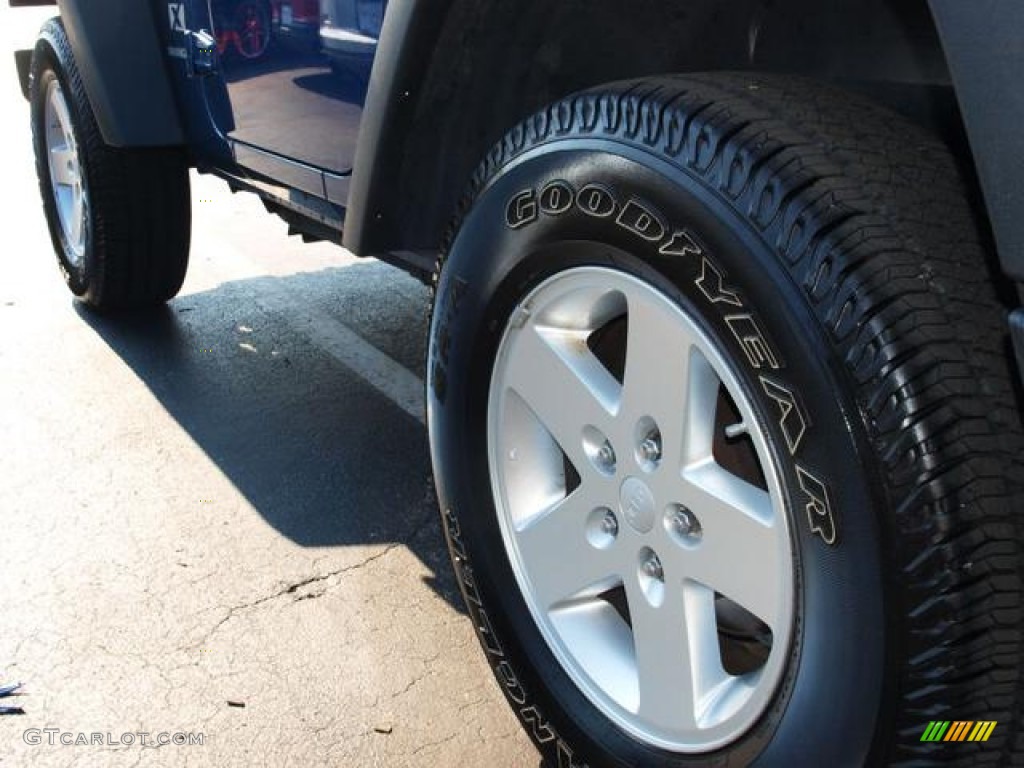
164;0;385;206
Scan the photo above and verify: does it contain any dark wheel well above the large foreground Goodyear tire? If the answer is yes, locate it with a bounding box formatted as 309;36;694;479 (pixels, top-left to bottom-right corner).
358;0;971;257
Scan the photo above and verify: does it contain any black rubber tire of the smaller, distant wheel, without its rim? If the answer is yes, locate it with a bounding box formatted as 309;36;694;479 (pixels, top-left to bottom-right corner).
30;18;191;308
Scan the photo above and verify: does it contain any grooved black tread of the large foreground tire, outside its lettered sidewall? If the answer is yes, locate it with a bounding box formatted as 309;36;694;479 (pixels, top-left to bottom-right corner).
434;73;1024;766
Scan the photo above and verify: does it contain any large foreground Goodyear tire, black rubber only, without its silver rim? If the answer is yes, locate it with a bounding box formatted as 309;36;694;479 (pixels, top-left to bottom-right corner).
427;74;1024;768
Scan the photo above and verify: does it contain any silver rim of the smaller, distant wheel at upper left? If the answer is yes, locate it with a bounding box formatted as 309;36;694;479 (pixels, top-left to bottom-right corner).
44;78;88;268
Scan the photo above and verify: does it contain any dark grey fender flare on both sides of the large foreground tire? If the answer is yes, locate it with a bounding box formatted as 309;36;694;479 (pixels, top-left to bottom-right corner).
352;0;1024;283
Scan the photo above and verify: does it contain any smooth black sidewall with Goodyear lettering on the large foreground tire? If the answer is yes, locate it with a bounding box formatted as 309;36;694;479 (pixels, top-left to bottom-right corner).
428;144;886;766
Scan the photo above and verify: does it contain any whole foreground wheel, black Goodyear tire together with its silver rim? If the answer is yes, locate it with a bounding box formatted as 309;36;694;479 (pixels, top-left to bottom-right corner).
428;75;1024;766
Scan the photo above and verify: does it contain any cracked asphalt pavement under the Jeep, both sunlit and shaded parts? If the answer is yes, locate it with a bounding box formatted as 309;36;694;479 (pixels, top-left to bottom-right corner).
0;6;539;768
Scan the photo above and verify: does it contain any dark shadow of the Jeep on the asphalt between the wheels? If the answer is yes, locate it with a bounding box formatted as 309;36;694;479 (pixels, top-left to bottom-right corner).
76;262;464;611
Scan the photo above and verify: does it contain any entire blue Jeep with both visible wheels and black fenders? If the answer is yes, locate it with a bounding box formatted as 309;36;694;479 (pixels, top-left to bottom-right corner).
9;0;1024;767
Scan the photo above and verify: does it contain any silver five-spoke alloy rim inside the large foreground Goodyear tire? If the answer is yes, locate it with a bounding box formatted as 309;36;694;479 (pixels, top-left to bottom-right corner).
487;267;795;753
